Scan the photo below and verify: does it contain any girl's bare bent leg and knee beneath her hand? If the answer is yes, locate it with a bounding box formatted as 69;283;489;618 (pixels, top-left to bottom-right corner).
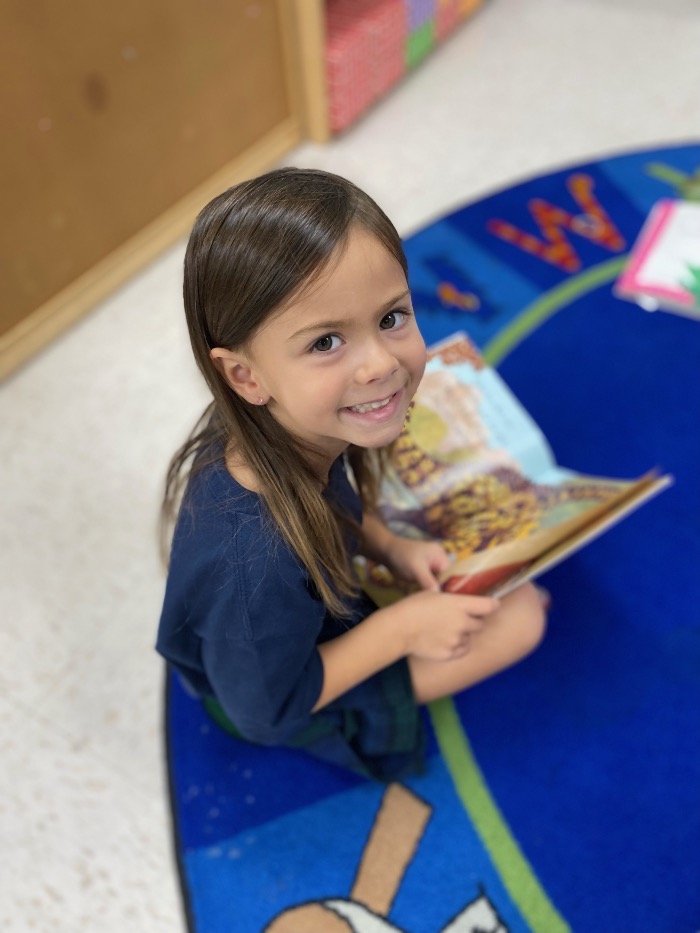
408;583;546;703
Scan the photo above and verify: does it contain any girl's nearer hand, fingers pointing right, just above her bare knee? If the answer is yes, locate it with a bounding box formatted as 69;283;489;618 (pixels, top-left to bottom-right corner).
385;590;500;661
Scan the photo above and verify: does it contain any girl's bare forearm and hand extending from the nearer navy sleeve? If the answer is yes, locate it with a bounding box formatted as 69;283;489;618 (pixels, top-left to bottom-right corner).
313;591;499;712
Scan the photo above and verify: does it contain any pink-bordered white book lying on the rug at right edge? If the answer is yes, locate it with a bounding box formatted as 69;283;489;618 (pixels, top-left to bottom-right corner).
614;198;700;319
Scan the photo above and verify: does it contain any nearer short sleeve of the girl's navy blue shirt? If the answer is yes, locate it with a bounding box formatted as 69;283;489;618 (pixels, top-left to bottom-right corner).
201;510;325;745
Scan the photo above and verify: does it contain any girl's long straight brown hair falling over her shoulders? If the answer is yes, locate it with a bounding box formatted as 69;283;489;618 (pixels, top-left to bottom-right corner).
162;168;408;616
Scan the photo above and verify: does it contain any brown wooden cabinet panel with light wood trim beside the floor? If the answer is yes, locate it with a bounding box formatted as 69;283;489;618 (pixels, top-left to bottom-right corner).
0;0;312;375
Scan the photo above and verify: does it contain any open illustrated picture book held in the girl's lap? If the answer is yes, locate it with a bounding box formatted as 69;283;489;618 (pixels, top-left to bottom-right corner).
357;334;672;605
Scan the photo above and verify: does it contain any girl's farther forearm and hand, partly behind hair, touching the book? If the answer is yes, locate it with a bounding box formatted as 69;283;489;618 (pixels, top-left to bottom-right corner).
360;513;450;590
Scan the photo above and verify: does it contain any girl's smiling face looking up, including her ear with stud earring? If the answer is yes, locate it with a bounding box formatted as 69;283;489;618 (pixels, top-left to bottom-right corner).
232;227;426;474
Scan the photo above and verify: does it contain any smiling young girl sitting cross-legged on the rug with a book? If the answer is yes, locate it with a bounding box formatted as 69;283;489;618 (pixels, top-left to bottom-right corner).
157;168;544;780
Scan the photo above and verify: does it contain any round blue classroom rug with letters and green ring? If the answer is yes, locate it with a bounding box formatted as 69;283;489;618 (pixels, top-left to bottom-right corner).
165;145;700;933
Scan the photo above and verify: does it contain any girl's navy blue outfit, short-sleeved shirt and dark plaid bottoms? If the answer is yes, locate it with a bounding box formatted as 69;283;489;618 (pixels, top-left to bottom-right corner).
157;458;422;777
